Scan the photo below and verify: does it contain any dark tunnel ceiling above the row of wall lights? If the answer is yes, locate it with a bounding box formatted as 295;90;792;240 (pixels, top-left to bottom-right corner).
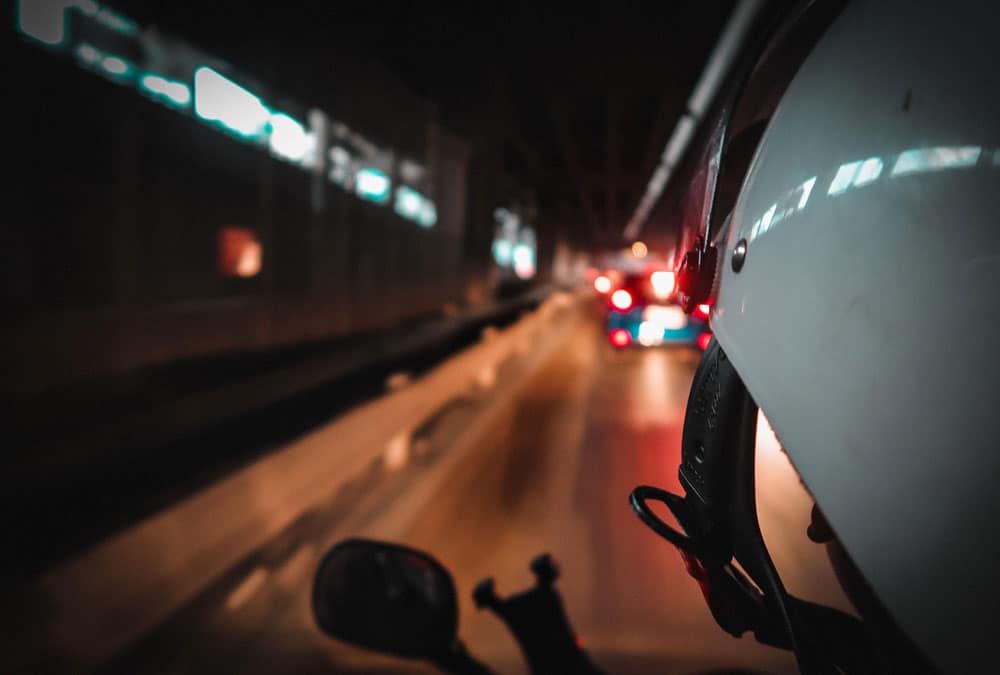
123;0;734;245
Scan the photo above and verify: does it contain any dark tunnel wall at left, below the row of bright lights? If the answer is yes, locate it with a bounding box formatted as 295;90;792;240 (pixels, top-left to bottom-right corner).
0;37;488;394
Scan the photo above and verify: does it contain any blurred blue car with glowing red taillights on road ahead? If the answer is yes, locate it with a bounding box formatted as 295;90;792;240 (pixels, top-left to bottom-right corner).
605;269;712;350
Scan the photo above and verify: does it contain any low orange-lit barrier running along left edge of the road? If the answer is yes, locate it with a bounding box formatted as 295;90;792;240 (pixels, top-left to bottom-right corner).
7;293;575;672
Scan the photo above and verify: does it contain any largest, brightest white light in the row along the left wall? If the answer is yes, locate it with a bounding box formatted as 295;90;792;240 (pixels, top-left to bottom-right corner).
194;66;271;137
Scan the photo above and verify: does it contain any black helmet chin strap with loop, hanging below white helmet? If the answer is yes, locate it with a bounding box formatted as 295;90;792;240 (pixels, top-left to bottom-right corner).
629;340;886;673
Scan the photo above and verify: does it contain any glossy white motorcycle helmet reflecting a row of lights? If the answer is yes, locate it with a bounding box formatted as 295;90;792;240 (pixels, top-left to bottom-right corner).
633;1;1000;672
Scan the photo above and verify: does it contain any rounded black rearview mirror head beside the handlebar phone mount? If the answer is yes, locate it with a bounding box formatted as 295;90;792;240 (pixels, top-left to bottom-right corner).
312;539;458;660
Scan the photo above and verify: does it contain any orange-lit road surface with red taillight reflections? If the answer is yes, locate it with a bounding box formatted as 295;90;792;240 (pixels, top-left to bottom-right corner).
99;315;844;675
